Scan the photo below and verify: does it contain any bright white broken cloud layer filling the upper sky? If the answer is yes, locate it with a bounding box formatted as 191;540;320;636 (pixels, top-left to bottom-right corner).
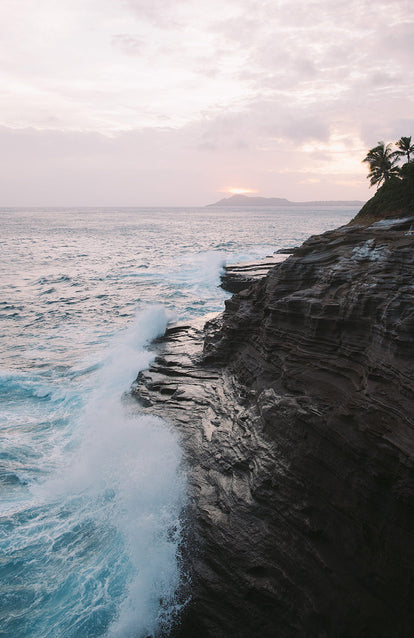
0;0;413;134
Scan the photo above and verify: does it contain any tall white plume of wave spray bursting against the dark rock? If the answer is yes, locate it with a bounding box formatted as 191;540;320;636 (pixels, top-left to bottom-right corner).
29;308;185;638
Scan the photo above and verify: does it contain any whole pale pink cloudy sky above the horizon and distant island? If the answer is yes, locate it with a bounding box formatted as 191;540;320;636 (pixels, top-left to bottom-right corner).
0;0;414;206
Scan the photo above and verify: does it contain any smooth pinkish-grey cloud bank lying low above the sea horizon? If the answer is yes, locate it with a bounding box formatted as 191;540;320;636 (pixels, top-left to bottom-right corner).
0;115;366;206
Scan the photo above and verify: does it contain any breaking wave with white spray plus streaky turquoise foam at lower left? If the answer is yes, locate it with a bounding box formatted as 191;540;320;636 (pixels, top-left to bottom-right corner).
2;308;185;638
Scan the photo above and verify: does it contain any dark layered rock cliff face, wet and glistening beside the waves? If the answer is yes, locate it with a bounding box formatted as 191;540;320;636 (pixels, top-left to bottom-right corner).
134;218;414;638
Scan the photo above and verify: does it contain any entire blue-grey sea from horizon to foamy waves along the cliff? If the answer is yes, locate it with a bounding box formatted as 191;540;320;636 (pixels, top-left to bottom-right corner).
0;207;357;638
